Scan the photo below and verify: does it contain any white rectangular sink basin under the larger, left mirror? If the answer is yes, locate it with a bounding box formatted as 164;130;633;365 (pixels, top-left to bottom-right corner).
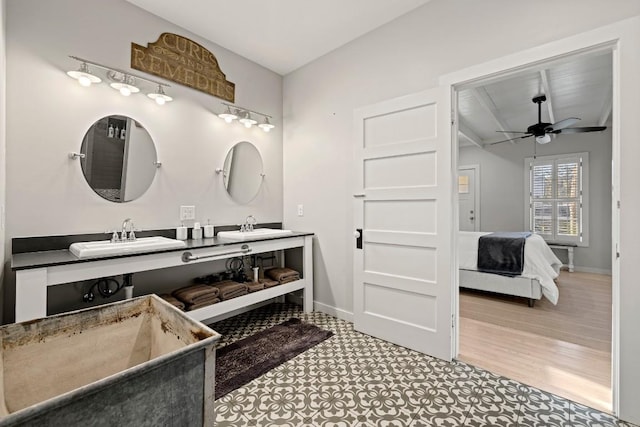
69;236;186;258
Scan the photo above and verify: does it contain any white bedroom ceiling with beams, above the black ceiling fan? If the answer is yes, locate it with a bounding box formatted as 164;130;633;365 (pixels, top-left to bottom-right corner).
458;52;613;148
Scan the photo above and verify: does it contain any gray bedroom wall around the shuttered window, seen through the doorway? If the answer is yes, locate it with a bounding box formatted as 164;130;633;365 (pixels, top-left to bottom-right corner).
458;128;611;274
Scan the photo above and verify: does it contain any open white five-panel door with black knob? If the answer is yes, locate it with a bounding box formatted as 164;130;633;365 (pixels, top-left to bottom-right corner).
353;88;453;360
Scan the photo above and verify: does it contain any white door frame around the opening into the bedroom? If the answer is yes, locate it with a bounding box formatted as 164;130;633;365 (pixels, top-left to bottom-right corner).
439;24;624;415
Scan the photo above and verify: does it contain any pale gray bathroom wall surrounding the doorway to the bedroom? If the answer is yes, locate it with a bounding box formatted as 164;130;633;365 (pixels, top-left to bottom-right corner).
283;0;640;422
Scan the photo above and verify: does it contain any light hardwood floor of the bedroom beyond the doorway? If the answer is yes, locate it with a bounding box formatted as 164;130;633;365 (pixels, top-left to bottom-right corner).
459;271;611;412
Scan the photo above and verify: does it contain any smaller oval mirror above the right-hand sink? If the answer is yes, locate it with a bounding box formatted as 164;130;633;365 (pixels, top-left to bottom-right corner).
222;141;264;204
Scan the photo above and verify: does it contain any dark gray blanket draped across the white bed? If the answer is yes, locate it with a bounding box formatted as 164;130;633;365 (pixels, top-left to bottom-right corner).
478;231;531;277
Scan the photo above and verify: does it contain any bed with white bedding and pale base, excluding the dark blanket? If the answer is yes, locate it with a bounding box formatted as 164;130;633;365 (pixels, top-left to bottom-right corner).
458;231;562;307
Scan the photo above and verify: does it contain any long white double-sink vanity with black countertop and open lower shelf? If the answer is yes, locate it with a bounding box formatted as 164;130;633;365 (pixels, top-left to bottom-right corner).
11;228;313;322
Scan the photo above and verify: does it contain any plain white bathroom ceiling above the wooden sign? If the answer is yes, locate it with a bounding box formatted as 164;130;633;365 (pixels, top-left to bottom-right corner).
127;0;430;75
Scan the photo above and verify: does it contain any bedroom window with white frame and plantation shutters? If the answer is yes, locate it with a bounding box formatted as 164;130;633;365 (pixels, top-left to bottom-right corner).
525;153;589;246
